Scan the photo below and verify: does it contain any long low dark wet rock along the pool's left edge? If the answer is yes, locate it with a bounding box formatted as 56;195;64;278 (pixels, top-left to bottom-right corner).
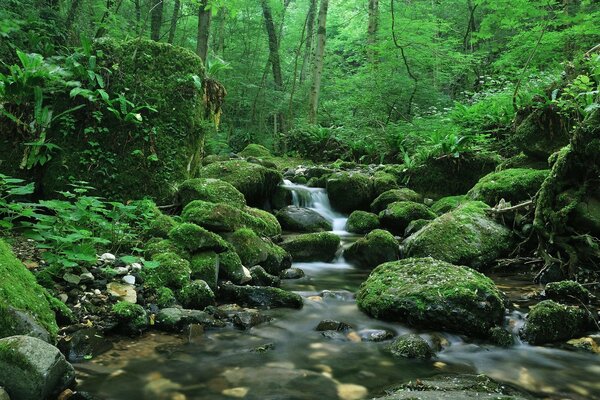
219;283;304;308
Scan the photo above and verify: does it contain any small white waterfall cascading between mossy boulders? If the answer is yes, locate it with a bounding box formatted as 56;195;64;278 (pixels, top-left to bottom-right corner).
283;180;348;235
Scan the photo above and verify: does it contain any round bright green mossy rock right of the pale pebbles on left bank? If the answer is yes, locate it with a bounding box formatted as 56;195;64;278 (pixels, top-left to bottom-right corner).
142;253;191;289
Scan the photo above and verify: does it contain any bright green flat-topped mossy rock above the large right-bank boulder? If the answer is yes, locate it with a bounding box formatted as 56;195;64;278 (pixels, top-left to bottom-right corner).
467;168;550;206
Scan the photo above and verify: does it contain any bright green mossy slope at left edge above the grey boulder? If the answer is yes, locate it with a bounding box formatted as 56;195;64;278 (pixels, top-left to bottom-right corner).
0;239;58;337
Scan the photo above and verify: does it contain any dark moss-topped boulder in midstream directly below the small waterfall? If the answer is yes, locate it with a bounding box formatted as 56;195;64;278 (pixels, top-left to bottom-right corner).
281;232;340;262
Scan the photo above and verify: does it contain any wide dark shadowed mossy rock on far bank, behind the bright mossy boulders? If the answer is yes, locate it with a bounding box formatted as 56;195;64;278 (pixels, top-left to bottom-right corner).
405;153;502;199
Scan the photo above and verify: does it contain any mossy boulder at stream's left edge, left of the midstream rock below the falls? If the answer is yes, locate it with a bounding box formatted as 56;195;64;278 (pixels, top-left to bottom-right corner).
225;228;291;275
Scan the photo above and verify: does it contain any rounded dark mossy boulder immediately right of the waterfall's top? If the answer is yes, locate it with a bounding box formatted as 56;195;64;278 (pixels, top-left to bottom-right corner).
327;172;373;213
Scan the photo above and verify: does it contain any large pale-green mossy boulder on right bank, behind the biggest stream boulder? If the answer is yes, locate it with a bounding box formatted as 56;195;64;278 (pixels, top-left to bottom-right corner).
403;202;514;270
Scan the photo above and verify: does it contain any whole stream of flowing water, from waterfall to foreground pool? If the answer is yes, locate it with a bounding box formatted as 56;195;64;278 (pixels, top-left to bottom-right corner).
77;182;600;400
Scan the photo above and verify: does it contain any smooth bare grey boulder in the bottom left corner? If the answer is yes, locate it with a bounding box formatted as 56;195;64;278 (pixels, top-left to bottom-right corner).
0;336;75;400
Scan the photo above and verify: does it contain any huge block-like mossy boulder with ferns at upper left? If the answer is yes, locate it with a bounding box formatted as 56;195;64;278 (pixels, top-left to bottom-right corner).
0;38;205;204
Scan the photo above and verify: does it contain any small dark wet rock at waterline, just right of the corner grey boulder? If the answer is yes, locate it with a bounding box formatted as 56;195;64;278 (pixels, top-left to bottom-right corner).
58;328;112;363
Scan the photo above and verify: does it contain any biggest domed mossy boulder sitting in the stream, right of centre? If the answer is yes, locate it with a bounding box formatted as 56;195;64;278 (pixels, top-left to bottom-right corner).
357;257;504;337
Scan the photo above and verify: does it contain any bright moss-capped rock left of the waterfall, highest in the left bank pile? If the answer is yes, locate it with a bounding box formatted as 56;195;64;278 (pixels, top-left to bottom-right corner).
177;178;246;208
